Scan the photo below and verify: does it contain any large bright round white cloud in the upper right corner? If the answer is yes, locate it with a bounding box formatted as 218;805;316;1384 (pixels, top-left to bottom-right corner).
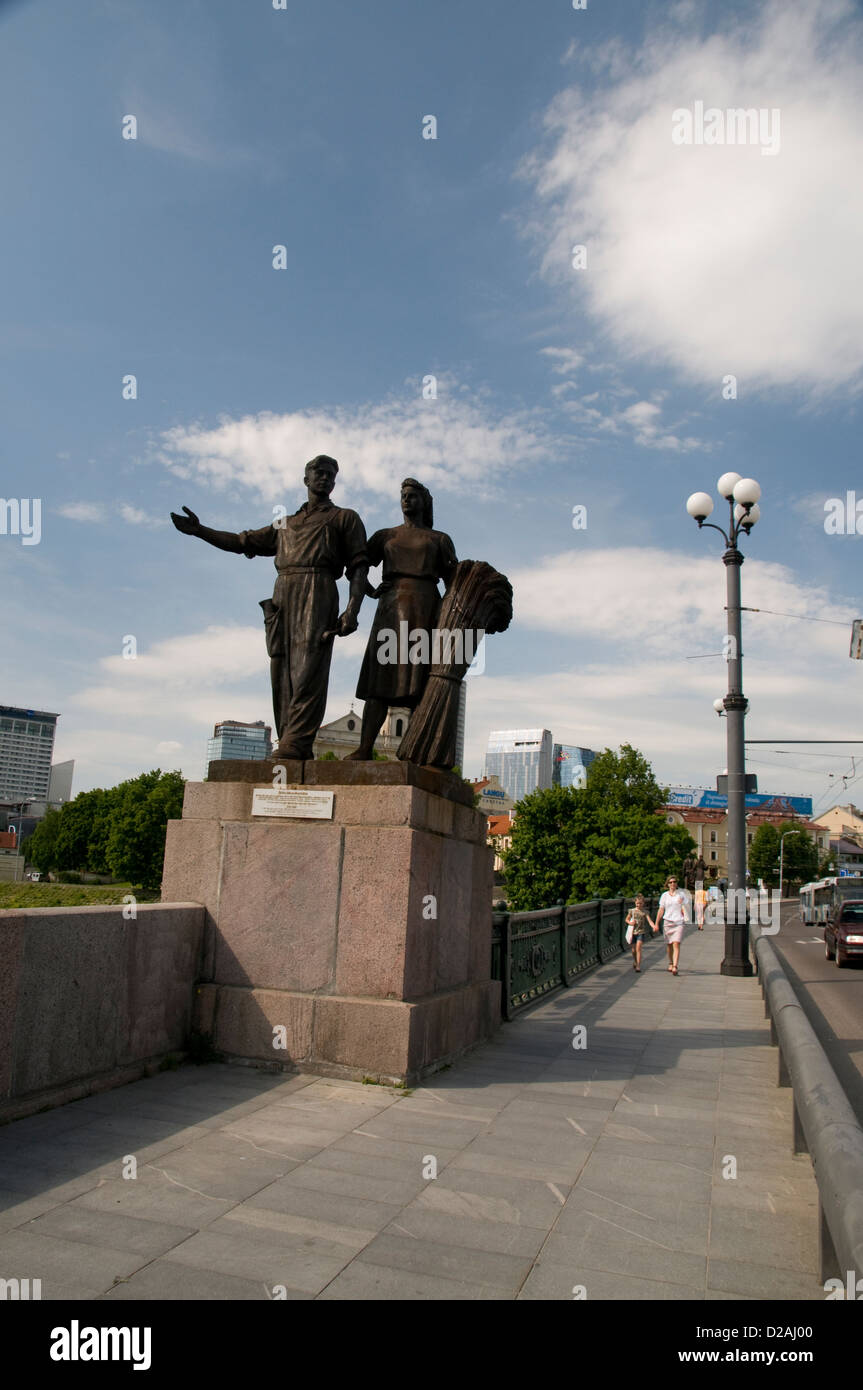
524;0;863;398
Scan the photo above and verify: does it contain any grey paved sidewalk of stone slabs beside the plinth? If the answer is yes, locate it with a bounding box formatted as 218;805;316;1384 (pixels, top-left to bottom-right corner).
0;929;824;1300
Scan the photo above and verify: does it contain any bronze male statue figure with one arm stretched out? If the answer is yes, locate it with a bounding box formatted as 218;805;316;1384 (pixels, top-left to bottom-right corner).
171;453;368;759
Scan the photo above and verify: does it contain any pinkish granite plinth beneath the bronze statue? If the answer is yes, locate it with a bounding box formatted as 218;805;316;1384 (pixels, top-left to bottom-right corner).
163;762;500;1081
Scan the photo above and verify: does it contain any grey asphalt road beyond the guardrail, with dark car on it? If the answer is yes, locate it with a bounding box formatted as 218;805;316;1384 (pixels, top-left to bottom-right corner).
770;898;863;1125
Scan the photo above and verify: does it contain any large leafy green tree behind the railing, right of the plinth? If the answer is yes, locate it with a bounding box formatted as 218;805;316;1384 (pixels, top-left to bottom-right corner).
504;744;695;910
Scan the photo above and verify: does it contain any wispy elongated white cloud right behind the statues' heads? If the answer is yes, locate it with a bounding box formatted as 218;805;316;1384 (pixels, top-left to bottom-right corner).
154;377;560;502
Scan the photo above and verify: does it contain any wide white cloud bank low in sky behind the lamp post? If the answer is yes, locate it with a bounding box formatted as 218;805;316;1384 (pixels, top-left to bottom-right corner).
466;546;863;795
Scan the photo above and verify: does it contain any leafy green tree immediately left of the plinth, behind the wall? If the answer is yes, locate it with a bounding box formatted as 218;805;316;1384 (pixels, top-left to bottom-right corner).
106;769;185;892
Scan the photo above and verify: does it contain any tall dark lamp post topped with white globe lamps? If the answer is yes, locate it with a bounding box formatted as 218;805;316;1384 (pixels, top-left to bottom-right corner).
687;473;762;976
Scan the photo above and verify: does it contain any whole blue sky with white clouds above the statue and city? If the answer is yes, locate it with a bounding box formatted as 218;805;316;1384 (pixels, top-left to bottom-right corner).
0;0;863;805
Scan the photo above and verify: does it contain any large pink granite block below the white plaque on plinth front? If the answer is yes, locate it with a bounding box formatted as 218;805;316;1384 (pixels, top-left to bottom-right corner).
214;820;345;991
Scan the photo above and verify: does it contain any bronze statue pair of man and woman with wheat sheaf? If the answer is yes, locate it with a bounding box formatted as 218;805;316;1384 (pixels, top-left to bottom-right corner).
171;455;513;767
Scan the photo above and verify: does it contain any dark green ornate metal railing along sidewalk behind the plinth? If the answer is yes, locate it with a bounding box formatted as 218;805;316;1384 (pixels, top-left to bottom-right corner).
492;898;659;1020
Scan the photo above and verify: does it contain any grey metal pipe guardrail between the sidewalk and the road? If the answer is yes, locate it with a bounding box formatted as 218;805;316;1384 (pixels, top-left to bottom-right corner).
750;923;863;1283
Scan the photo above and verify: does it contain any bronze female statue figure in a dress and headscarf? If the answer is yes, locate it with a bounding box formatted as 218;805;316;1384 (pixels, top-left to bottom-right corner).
349;478;459;762
